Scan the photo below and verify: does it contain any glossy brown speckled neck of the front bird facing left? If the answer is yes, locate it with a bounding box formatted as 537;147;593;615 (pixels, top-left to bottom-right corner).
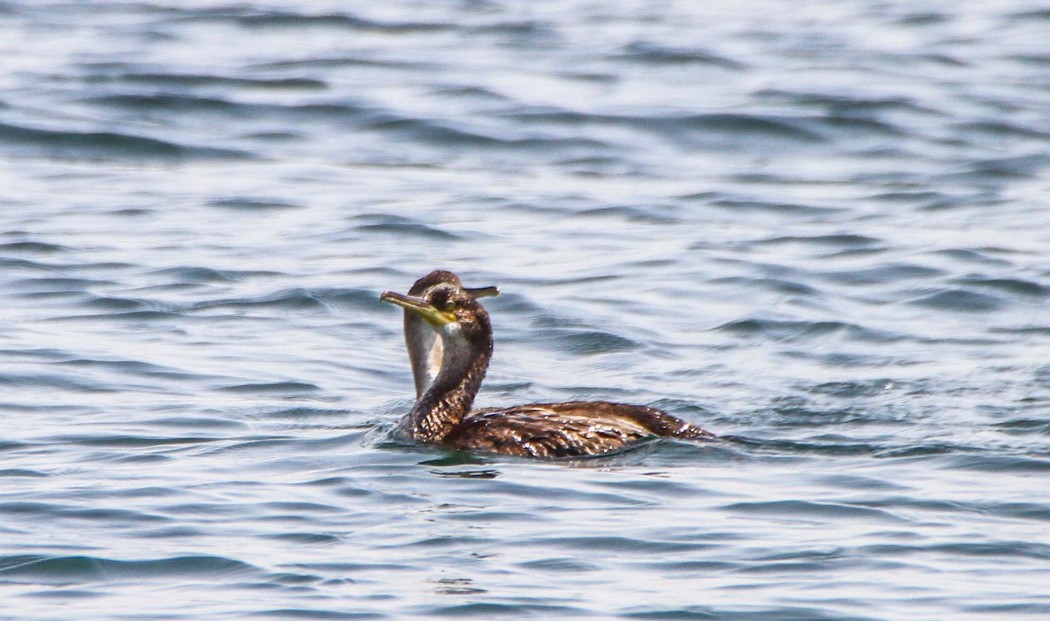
408;333;492;442
